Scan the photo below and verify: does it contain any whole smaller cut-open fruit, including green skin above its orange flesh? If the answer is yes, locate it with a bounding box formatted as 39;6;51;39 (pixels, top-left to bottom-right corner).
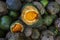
10;20;24;33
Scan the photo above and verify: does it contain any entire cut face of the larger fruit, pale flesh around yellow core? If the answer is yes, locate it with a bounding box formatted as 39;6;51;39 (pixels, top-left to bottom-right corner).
21;5;40;25
